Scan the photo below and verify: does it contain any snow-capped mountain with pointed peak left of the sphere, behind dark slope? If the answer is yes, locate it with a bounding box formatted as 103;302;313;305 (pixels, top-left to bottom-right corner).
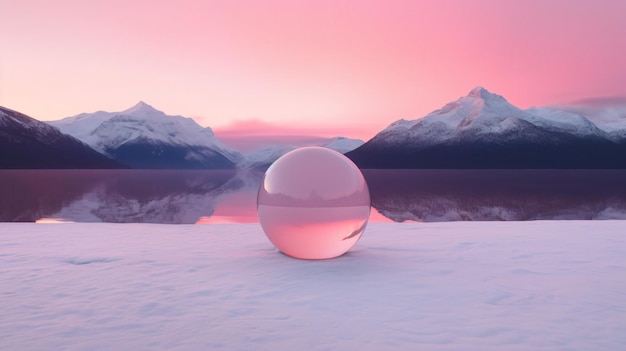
50;101;242;168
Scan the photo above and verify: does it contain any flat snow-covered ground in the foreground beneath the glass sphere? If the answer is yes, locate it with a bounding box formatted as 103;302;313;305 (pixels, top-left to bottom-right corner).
0;221;626;350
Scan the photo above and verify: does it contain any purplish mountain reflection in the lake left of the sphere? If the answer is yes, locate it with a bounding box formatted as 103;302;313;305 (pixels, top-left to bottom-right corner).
0;170;254;224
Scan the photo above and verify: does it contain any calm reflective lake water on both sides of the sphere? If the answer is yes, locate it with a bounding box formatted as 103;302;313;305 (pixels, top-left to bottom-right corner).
0;170;626;224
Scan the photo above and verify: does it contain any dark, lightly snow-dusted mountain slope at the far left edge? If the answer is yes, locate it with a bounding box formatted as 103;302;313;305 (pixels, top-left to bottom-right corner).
0;107;122;168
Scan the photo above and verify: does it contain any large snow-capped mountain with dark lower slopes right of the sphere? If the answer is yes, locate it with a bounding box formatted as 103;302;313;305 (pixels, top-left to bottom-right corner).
346;87;626;168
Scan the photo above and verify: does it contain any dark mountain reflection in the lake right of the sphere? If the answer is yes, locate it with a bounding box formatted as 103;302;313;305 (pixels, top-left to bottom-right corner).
365;170;626;222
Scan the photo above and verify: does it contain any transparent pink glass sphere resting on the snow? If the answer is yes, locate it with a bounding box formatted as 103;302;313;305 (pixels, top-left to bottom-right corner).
257;147;370;259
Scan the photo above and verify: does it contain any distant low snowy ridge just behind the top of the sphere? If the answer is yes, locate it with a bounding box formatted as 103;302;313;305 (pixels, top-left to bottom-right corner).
240;137;363;168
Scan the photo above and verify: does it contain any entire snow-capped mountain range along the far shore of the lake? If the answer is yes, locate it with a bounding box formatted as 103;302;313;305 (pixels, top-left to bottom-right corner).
0;87;626;169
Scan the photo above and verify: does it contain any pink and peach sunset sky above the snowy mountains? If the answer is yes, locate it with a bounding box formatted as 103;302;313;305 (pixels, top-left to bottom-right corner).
0;0;626;139
